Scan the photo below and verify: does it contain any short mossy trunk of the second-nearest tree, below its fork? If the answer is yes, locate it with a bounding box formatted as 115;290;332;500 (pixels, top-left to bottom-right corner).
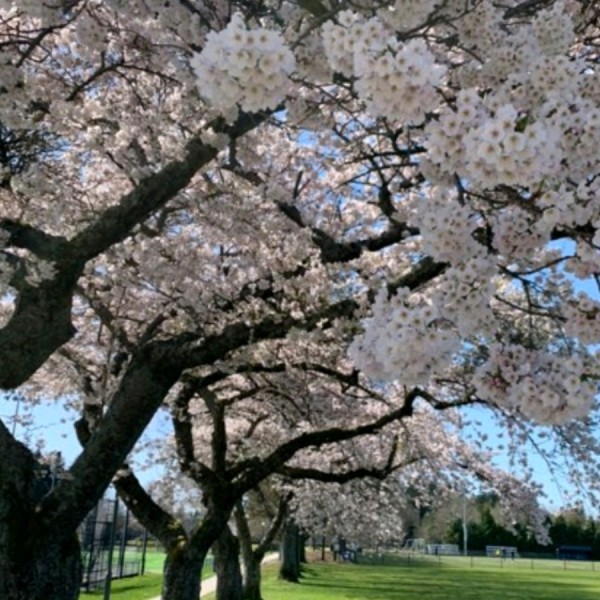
162;541;206;600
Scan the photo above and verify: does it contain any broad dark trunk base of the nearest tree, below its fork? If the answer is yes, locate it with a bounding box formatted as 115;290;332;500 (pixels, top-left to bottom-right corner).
0;532;82;600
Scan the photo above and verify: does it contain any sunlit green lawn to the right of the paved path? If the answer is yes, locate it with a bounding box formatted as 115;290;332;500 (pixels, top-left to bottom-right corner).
207;562;600;600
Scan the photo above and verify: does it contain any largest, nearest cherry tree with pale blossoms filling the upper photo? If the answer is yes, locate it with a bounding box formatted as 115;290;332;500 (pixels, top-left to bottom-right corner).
0;0;600;600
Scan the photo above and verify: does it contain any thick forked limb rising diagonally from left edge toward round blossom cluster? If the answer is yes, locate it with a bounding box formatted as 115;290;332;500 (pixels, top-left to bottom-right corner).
0;113;269;389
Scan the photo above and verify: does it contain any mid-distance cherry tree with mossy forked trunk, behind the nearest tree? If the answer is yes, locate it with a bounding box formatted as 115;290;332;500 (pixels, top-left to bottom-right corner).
115;352;418;598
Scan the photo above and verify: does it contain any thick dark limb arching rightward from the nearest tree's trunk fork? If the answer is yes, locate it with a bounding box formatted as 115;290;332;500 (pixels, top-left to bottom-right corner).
38;290;356;535
